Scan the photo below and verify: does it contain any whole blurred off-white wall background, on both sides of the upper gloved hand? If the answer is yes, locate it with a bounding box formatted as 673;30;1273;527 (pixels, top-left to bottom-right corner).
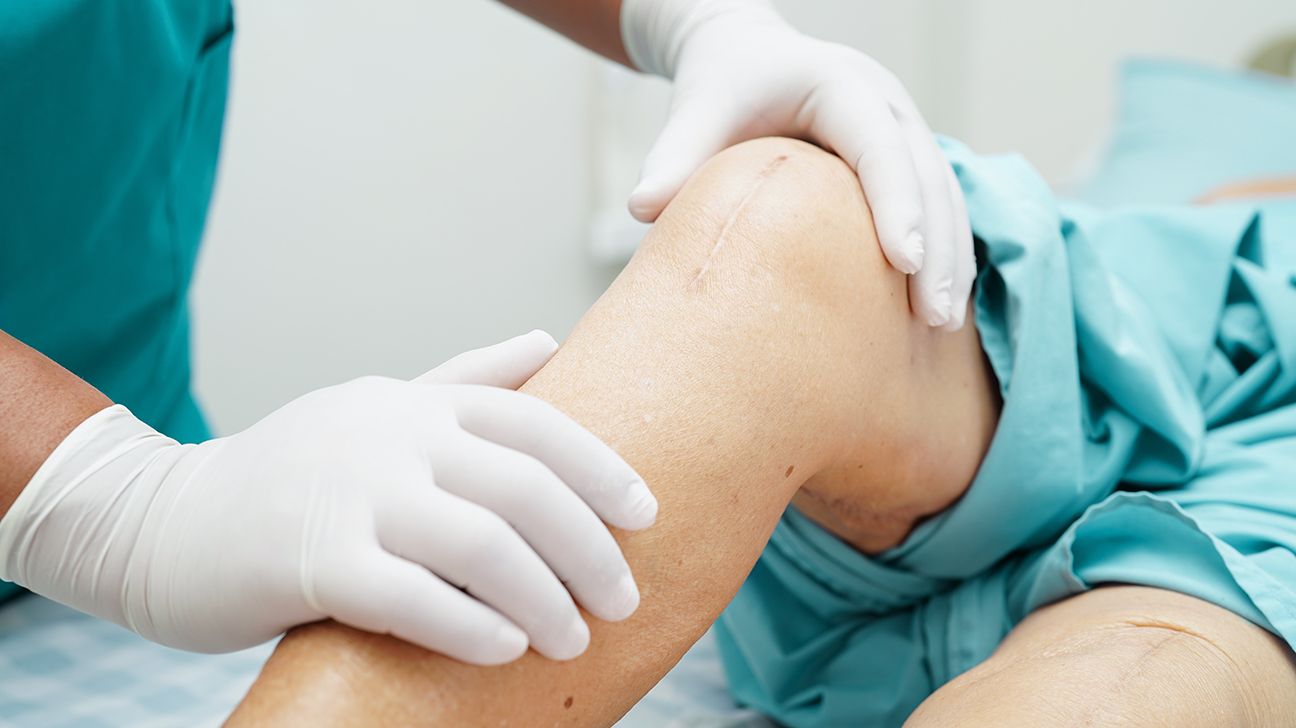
193;0;1296;433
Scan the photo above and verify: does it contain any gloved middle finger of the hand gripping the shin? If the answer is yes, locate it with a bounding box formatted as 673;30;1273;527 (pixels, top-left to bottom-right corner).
435;427;639;622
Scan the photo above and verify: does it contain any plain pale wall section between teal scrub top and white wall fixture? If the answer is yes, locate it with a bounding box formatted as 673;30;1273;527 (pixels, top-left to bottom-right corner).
193;0;610;431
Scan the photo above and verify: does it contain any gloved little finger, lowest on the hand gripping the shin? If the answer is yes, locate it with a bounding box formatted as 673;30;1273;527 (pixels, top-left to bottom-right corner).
316;547;526;665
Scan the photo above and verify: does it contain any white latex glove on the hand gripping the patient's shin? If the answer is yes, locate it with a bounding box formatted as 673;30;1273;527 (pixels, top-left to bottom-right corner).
0;332;657;665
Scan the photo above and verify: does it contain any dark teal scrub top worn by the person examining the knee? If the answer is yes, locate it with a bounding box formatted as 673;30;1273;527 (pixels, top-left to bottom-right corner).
0;0;233;593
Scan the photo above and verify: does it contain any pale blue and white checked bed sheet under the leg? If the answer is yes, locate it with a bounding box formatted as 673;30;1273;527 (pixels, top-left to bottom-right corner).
0;596;772;728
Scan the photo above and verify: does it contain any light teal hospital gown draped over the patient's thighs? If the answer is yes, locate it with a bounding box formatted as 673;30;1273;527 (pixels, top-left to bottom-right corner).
717;142;1296;727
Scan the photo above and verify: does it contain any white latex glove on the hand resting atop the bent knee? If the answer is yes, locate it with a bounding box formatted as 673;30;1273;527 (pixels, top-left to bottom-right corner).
621;0;976;330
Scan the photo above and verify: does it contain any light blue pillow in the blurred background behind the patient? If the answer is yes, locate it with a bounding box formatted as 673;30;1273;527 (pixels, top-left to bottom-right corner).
1077;60;1296;205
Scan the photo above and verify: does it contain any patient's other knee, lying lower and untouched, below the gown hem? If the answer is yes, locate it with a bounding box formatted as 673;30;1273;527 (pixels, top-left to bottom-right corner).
906;587;1296;728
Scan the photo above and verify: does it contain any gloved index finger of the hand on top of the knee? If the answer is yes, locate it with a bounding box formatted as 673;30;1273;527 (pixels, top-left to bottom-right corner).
810;80;928;273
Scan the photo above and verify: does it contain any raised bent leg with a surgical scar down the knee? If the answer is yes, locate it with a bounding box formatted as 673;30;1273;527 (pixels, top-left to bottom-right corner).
233;140;997;725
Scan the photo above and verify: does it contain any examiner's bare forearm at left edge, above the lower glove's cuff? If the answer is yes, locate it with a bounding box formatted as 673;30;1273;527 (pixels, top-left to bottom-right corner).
0;332;111;517
